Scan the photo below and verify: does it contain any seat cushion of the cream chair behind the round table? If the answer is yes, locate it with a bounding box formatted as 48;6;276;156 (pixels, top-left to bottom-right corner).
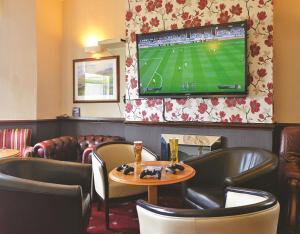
108;179;147;198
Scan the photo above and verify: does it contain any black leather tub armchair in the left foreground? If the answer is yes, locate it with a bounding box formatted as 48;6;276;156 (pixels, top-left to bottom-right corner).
0;158;92;234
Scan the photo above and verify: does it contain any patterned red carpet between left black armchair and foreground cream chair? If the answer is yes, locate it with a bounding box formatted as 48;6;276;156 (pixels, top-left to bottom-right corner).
87;201;139;234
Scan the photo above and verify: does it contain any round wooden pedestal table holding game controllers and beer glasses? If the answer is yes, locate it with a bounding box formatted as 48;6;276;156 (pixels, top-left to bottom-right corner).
109;161;196;205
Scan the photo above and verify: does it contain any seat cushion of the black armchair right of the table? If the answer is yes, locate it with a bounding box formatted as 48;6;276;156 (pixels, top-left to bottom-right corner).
185;185;225;209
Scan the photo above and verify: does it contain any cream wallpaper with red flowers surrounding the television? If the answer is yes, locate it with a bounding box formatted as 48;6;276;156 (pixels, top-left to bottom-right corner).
125;0;273;123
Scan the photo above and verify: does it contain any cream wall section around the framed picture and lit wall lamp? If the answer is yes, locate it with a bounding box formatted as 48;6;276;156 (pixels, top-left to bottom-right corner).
61;0;127;117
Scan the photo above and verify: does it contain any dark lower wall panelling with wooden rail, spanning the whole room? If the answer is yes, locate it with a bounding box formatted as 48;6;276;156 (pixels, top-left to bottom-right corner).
0;118;299;154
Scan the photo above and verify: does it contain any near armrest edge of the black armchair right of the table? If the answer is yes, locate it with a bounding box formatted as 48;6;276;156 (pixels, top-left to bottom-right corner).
224;158;278;186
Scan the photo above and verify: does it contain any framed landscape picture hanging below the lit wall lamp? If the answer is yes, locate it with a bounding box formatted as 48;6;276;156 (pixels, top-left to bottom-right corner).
73;56;120;103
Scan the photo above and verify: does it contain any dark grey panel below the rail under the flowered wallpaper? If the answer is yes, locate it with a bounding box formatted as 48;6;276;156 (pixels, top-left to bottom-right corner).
125;124;273;153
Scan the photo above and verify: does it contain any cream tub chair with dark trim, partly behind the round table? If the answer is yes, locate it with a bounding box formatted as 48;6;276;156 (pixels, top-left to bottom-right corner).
92;142;158;228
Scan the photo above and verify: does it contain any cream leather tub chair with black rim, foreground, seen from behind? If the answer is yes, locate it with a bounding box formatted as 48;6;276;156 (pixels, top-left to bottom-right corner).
137;187;279;234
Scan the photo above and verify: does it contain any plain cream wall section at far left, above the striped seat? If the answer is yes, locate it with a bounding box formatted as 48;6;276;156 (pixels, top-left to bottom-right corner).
0;0;37;120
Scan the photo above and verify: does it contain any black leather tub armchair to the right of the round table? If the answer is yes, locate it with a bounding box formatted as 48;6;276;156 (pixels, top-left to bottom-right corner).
183;147;278;209
